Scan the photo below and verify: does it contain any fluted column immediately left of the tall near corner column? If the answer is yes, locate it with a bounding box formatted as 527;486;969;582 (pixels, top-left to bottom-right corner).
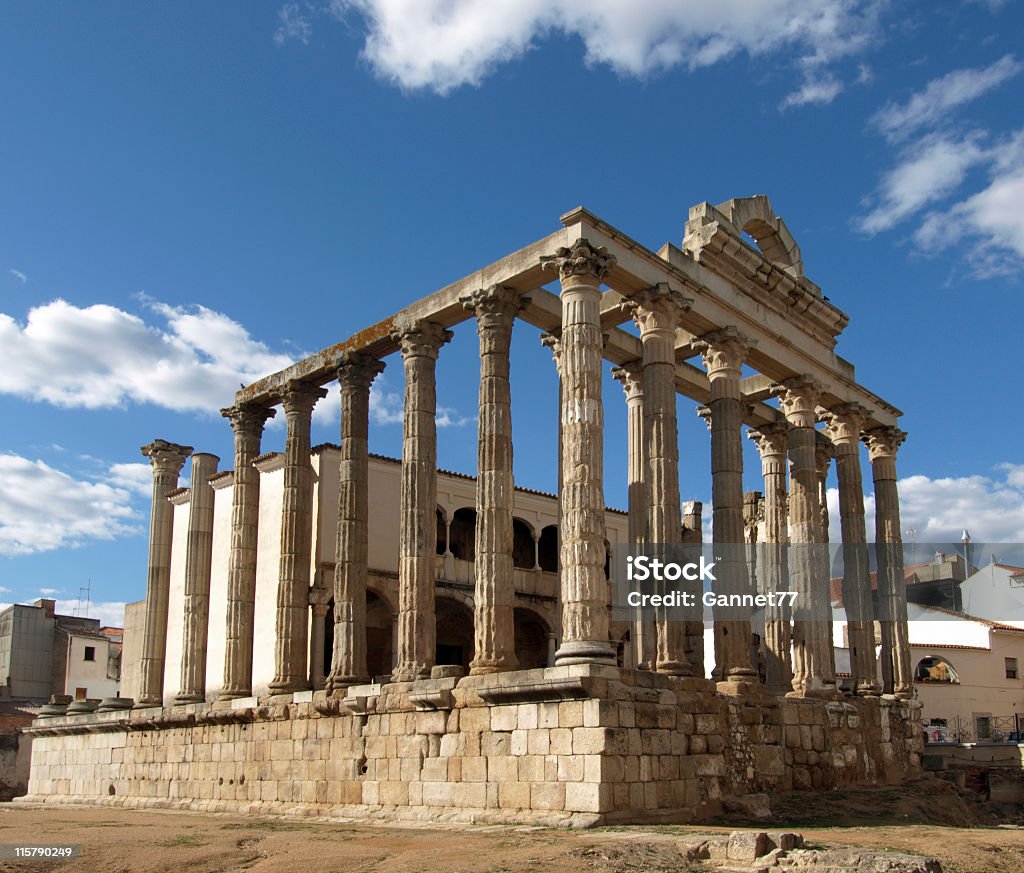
463;286;524;674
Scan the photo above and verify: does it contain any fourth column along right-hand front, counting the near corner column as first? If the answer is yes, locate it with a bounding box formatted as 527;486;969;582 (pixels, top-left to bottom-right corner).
772;376;836;697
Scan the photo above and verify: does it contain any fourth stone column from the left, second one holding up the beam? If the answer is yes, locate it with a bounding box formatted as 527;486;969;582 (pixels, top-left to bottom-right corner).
270;381;327;694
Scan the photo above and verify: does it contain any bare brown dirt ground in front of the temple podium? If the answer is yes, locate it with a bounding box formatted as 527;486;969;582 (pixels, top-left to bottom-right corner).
0;783;1024;873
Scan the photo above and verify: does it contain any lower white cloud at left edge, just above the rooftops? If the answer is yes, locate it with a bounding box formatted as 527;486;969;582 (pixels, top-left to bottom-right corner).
0;454;140;556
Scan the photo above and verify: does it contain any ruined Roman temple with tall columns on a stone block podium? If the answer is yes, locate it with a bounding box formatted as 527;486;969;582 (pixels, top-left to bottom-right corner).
22;197;921;825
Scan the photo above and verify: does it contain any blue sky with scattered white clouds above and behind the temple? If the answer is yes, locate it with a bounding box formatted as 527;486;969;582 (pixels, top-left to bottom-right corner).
0;0;1024;618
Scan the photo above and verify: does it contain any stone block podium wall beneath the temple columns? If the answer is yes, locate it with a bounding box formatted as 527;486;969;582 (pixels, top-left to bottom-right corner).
19;665;922;826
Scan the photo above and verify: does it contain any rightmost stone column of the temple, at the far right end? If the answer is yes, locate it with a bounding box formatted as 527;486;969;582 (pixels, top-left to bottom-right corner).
863;427;913;698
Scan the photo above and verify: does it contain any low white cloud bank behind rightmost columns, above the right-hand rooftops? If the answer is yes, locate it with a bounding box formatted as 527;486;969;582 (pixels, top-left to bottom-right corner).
828;464;1024;543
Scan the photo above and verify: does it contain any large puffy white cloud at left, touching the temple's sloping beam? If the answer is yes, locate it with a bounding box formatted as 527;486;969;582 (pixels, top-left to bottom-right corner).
0;300;292;412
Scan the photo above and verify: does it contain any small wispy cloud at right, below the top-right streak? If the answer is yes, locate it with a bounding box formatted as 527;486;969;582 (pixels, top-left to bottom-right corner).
859;131;988;233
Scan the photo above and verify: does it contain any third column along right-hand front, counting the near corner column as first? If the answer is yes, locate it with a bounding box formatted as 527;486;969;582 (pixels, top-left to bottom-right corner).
699;328;758;682
